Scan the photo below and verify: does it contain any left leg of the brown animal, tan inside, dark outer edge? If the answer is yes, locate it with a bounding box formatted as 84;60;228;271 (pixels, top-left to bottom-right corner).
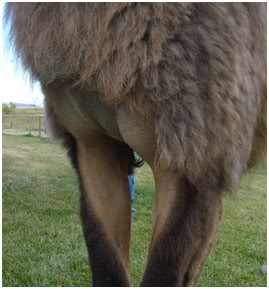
76;135;132;286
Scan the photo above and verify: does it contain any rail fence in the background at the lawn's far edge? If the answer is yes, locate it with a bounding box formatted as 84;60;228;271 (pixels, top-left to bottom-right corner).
2;114;48;137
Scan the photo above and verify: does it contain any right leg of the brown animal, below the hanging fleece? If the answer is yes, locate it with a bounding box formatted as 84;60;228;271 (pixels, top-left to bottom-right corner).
141;171;222;286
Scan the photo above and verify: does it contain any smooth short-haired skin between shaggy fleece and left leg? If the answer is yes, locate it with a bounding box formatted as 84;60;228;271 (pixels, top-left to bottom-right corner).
44;86;122;141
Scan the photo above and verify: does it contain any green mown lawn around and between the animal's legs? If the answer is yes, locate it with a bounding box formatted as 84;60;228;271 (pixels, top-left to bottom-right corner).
2;136;266;287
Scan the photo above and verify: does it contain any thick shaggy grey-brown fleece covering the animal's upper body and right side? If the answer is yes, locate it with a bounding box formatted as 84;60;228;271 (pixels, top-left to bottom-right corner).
6;3;266;191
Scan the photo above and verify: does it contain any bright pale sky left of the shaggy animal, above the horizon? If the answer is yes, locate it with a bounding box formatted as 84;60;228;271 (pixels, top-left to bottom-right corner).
0;2;44;106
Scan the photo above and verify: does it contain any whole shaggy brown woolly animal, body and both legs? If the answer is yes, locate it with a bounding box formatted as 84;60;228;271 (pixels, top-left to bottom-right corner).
6;3;266;286
